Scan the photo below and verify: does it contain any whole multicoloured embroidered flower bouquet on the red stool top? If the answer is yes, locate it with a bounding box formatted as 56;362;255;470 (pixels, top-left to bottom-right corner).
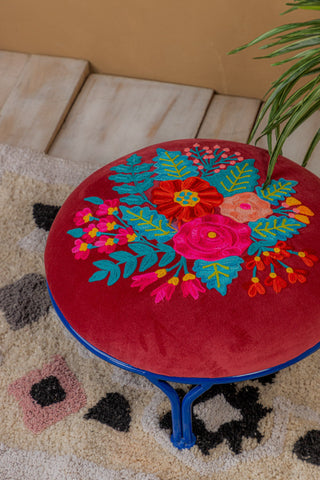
68;143;318;304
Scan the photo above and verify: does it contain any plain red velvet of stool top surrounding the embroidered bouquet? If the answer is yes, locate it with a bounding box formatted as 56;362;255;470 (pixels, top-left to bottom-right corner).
45;139;320;378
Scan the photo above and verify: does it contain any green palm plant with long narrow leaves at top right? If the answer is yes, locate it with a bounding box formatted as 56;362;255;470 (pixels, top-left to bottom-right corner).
230;0;320;186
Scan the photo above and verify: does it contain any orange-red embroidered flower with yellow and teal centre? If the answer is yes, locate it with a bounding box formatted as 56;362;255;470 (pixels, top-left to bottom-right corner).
152;177;223;222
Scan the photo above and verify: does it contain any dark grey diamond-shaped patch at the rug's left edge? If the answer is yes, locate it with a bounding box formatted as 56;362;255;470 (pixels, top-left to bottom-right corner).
0;273;51;330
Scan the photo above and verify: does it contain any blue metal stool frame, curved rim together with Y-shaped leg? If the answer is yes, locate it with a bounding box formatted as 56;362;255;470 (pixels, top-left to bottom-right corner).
48;286;320;449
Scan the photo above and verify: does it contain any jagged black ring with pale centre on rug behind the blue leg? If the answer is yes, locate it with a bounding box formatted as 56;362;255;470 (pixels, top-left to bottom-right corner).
160;384;272;455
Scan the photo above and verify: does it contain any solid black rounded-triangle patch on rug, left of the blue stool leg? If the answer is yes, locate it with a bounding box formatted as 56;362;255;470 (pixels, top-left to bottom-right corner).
84;392;131;432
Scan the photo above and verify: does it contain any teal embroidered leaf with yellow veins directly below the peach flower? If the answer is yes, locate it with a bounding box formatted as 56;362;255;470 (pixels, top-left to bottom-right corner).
249;215;306;243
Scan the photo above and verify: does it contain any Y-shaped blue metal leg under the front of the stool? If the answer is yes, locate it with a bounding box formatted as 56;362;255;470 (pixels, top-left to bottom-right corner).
147;377;214;449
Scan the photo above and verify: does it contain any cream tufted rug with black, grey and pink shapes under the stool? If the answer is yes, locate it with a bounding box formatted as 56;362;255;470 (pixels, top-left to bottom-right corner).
0;145;320;480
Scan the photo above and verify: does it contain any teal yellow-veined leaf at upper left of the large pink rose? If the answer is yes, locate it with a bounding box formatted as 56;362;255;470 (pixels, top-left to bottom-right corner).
120;206;176;242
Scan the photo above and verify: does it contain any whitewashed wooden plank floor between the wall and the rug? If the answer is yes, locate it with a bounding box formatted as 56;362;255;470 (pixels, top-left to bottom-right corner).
0;51;320;176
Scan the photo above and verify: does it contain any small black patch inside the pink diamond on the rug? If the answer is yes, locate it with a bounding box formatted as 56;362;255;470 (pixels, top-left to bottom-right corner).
30;375;66;407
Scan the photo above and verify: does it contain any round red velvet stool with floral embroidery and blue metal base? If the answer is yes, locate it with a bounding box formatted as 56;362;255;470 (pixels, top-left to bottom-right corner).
45;139;320;448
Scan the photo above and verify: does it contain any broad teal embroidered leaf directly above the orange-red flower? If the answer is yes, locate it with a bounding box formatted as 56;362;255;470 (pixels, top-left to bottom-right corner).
153;148;198;180
